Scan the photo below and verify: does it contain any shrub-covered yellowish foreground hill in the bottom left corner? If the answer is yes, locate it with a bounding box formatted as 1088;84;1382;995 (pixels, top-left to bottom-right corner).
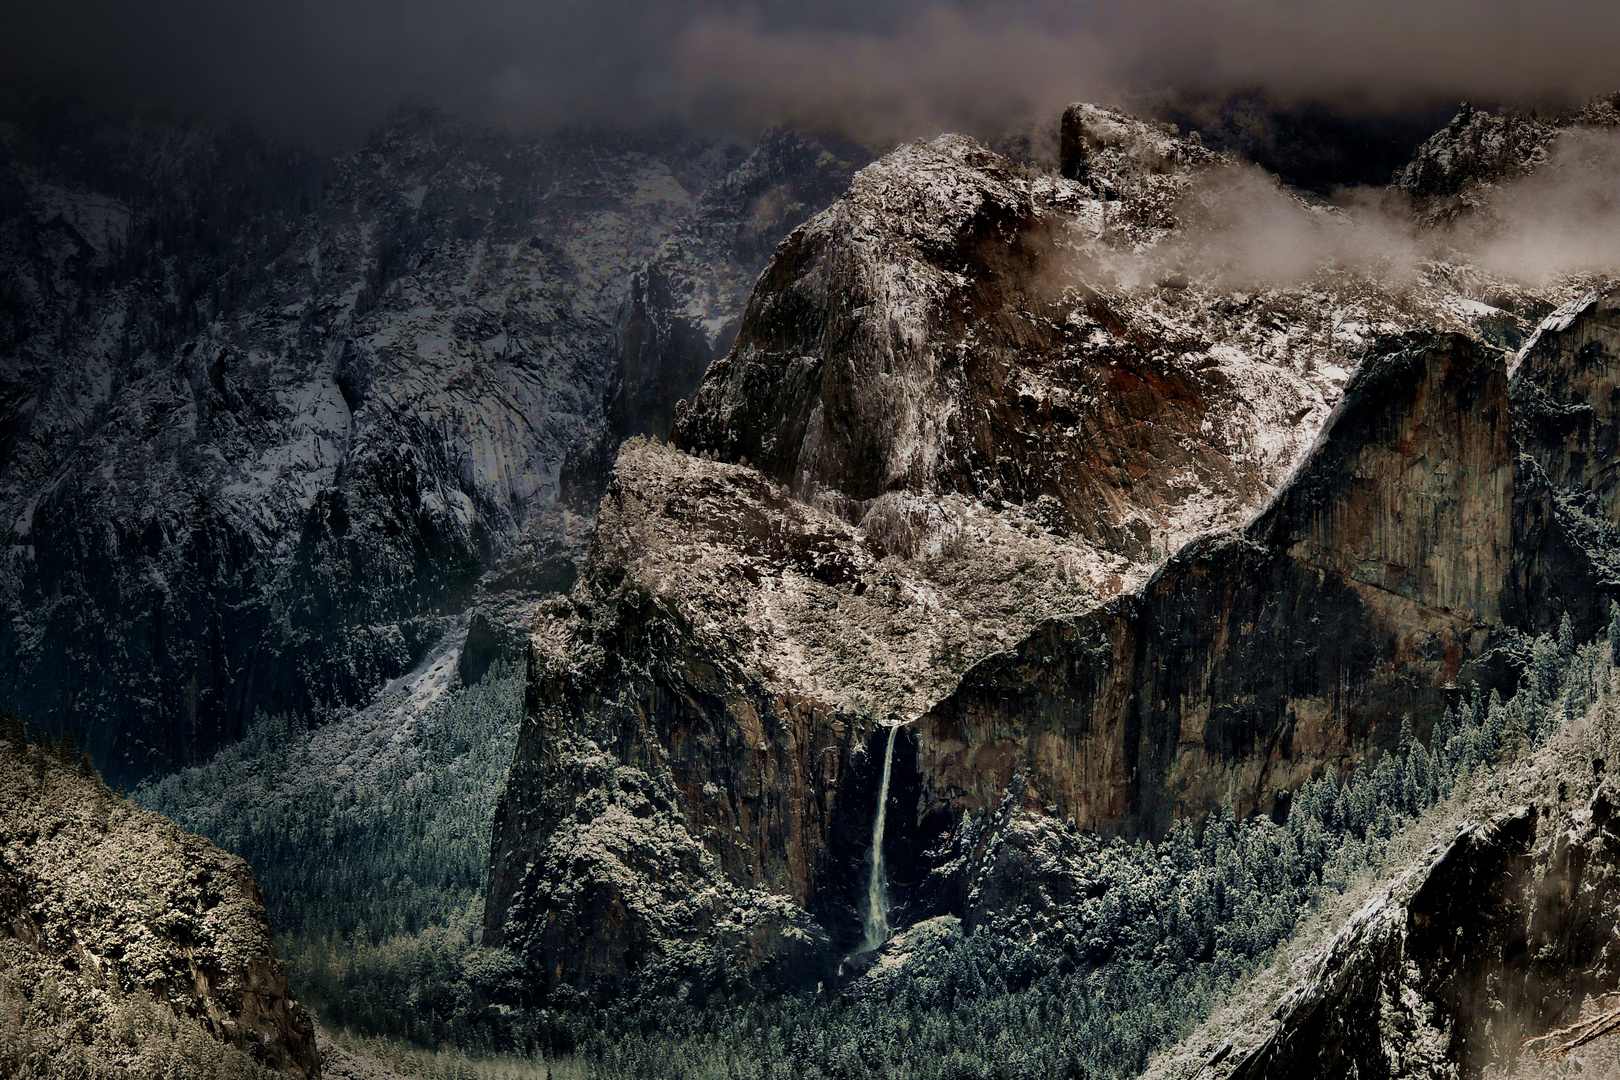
0;714;321;1080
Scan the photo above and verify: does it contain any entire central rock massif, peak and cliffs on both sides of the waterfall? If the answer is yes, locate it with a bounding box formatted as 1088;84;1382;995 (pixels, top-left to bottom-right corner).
486;107;1587;991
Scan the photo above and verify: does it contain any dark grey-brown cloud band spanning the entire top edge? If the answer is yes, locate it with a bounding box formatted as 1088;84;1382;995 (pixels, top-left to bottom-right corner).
9;0;1620;139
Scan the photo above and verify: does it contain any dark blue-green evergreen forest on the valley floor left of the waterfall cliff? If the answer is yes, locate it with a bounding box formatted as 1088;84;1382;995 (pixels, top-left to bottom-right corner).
136;664;523;1049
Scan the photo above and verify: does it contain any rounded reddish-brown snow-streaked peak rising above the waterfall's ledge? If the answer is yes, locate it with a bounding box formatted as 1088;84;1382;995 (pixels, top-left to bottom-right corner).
672;120;1341;560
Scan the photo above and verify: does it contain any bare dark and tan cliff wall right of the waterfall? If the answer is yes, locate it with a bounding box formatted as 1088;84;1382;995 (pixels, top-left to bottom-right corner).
915;335;1513;836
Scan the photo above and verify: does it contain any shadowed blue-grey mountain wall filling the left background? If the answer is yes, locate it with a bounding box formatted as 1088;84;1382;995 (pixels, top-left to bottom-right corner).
0;107;842;779
